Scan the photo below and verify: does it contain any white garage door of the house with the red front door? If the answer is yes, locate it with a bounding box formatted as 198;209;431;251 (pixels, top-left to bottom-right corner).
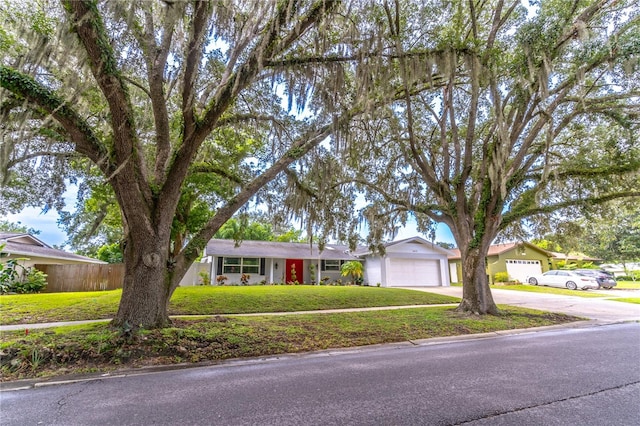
387;259;442;287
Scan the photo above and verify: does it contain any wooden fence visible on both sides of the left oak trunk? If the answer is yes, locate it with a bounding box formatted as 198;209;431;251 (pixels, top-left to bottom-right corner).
35;263;210;293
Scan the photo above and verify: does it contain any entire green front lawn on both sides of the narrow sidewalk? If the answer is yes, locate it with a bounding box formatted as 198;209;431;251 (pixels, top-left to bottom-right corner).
0;286;578;381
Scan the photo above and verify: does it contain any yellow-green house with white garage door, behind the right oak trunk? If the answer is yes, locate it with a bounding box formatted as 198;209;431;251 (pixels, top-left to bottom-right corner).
449;242;553;284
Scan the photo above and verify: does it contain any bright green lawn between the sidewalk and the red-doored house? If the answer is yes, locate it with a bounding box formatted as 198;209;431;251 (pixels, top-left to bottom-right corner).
0;286;459;325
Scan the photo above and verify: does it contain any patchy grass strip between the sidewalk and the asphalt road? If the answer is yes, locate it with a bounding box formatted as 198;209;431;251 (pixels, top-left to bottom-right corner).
0;304;576;380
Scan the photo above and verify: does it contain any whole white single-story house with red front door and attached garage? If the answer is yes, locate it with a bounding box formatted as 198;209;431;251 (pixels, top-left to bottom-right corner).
203;237;450;287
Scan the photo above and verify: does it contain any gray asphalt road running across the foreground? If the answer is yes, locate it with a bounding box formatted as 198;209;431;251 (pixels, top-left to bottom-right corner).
0;323;640;426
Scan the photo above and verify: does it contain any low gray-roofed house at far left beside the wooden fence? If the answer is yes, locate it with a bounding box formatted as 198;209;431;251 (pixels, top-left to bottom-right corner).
0;232;106;267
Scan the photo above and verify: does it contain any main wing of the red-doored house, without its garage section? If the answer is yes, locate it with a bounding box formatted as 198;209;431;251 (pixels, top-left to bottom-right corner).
203;239;359;284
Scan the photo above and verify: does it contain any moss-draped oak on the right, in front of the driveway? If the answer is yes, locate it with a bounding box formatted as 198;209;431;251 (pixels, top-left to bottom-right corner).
280;0;640;314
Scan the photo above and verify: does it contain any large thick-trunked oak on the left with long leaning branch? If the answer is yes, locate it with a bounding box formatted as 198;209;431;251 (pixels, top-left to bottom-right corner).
0;0;364;327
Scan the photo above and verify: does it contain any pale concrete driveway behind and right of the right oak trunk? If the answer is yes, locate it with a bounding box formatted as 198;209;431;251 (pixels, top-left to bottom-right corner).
406;287;640;323
